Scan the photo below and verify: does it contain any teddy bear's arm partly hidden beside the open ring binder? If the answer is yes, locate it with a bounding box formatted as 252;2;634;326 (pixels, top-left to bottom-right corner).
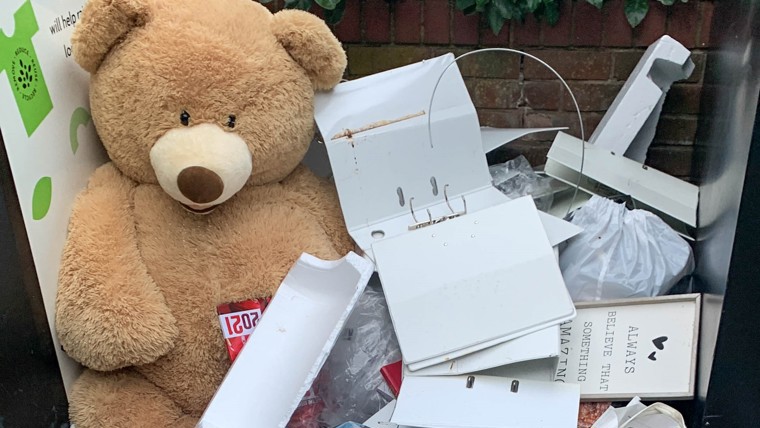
282;165;354;255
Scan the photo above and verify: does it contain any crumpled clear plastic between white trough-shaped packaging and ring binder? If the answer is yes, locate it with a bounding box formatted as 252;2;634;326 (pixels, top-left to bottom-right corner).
315;275;401;426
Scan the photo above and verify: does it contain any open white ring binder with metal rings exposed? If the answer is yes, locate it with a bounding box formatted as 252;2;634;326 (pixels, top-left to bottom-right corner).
315;54;579;371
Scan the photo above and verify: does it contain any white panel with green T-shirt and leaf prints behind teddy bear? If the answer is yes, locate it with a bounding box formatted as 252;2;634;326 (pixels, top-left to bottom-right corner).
0;0;106;390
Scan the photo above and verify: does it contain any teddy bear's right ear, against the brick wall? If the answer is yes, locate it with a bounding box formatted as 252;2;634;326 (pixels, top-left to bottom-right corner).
272;9;346;90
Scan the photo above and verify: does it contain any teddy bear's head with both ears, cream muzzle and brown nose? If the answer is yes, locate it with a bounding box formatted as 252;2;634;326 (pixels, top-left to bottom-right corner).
72;0;346;213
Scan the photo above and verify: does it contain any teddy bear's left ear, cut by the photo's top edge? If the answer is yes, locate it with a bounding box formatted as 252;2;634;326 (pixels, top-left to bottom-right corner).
71;0;149;73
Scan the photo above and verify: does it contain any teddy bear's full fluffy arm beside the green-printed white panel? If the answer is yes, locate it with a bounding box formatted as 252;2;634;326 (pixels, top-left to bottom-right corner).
56;165;178;370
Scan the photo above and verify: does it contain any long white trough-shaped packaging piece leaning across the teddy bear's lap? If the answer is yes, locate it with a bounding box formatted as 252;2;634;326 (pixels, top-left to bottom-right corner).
197;253;373;428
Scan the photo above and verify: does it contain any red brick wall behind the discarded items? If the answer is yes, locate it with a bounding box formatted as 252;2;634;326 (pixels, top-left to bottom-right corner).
270;0;713;179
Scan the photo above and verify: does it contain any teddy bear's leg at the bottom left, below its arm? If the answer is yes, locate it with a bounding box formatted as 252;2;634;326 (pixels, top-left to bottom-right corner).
69;370;197;428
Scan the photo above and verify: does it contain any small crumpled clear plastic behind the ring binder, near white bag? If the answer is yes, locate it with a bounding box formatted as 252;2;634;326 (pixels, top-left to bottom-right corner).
488;155;554;211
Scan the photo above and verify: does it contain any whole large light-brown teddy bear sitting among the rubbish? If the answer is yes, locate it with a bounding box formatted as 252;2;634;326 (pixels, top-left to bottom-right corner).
56;0;352;428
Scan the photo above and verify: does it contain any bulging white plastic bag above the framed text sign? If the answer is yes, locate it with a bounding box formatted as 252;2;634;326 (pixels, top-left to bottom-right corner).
559;196;694;302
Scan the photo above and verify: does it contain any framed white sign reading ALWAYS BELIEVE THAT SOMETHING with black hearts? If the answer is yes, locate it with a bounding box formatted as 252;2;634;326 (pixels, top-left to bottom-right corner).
555;294;700;401
